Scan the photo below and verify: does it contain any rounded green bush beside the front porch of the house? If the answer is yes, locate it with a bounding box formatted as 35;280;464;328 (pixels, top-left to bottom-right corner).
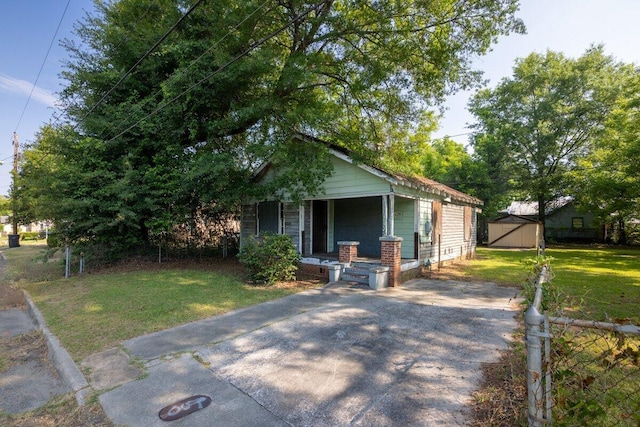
238;233;300;285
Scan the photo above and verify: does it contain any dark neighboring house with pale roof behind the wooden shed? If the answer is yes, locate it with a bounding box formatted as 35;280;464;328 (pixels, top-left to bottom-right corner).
489;197;604;247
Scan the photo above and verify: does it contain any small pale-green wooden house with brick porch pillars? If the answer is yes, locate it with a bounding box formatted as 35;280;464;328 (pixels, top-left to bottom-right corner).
240;139;482;286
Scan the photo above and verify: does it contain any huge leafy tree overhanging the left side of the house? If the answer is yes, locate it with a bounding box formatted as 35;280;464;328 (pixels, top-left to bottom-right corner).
25;0;523;251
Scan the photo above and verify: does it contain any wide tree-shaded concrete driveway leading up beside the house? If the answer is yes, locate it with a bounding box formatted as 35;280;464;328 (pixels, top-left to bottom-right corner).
196;281;517;426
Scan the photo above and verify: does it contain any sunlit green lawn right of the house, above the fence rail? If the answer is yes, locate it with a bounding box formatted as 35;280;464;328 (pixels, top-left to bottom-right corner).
462;245;640;324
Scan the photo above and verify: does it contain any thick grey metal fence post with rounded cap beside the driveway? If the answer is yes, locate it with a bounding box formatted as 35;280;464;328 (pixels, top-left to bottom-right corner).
524;305;544;427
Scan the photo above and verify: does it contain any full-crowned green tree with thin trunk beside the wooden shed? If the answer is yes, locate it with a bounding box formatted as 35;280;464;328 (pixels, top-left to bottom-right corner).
469;46;629;231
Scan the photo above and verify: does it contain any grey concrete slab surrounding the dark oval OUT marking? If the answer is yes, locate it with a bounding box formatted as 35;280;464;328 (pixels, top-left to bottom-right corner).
99;354;287;427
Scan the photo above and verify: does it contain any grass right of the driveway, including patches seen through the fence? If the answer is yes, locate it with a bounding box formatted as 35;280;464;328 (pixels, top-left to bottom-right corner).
444;246;640;426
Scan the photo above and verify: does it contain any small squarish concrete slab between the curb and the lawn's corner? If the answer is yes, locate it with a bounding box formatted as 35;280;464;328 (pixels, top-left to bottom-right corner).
80;348;143;391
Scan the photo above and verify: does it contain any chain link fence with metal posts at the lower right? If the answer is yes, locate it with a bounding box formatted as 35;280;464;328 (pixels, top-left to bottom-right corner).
525;266;640;427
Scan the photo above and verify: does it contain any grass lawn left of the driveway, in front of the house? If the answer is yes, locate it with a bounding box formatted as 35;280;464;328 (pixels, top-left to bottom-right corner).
4;245;320;361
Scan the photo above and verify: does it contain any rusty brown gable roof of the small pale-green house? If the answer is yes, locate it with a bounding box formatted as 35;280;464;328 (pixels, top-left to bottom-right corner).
254;134;484;206
